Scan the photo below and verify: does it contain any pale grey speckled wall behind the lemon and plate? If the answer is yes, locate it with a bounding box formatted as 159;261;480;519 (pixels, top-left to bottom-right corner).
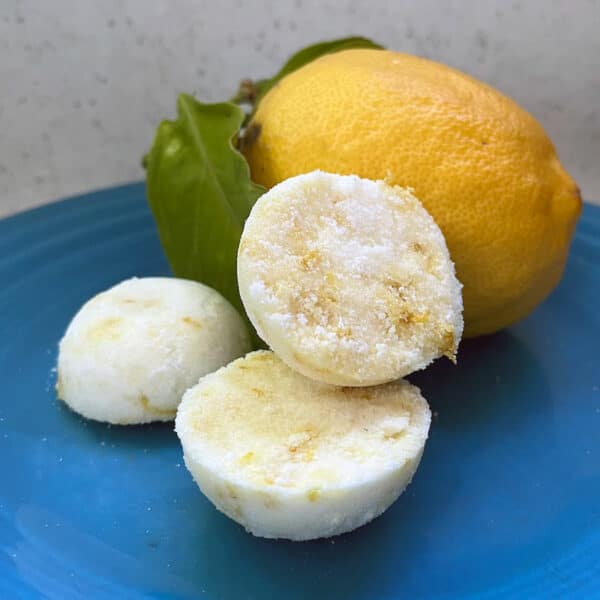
0;0;600;215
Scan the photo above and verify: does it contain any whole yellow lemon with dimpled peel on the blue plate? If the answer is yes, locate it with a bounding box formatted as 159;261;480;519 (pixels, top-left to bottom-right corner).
242;50;581;336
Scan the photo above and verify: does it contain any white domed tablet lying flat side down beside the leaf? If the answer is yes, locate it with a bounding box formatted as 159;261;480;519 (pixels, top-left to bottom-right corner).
56;277;251;424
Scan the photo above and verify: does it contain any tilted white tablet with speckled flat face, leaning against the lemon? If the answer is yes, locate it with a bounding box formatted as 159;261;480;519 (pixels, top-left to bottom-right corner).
238;171;463;386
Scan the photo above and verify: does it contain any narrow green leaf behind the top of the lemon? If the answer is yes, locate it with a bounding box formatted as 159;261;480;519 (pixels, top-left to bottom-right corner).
232;36;383;113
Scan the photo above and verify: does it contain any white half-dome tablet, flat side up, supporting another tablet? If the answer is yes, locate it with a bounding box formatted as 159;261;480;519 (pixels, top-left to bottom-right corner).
175;351;431;540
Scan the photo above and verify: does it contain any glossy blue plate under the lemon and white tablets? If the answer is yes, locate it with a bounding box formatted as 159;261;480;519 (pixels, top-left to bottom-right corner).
0;184;600;600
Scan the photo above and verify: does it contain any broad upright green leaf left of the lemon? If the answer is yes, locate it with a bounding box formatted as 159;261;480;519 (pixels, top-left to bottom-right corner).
144;94;265;340
